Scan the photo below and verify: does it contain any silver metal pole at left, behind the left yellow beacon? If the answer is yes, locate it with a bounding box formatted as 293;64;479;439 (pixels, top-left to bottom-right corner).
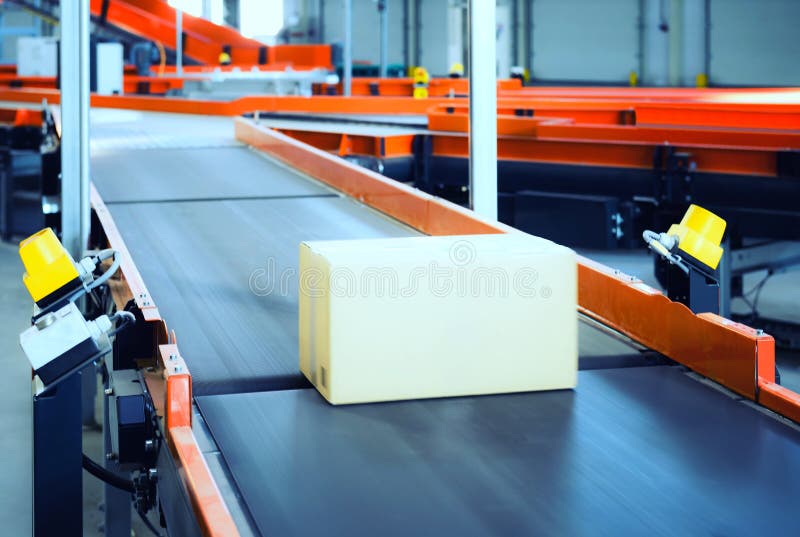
60;0;89;259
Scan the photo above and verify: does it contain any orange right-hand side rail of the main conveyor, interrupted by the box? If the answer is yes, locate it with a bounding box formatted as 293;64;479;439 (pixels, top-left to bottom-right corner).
235;118;800;417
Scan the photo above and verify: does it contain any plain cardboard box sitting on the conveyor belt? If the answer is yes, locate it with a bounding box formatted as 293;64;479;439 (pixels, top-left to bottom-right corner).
299;233;578;404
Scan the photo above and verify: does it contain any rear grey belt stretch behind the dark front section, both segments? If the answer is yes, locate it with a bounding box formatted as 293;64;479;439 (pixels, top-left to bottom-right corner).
92;129;652;394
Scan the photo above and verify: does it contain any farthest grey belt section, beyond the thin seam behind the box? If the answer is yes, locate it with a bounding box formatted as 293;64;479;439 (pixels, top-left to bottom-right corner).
92;147;332;203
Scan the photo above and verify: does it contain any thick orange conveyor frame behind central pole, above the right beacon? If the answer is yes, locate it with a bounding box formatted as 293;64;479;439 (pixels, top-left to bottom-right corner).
428;103;800;176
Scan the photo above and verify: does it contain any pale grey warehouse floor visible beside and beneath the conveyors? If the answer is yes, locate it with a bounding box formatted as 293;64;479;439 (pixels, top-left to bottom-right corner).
0;243;800;535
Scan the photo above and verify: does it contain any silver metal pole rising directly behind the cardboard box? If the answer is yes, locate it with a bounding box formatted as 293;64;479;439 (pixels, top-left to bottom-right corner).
469;0;497;220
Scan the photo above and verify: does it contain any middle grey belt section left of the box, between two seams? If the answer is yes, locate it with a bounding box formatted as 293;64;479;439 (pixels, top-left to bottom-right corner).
109;194;415;394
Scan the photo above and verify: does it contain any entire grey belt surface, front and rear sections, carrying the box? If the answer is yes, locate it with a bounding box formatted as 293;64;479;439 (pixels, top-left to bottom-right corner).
92;111;800;535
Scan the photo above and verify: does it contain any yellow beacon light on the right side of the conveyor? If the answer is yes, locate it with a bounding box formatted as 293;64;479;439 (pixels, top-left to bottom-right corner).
667;205;726;270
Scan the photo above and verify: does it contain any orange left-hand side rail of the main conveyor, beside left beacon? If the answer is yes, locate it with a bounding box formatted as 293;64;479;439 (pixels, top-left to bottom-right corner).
90;185;239;537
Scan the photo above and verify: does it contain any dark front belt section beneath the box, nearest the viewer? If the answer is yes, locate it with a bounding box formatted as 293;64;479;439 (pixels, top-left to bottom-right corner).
198;366;800;537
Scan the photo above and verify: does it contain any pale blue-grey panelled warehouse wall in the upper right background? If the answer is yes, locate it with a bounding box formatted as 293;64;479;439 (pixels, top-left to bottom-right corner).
296;0;800;86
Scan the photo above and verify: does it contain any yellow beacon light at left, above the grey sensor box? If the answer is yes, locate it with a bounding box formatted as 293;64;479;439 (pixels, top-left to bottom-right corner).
19;228;81;307
